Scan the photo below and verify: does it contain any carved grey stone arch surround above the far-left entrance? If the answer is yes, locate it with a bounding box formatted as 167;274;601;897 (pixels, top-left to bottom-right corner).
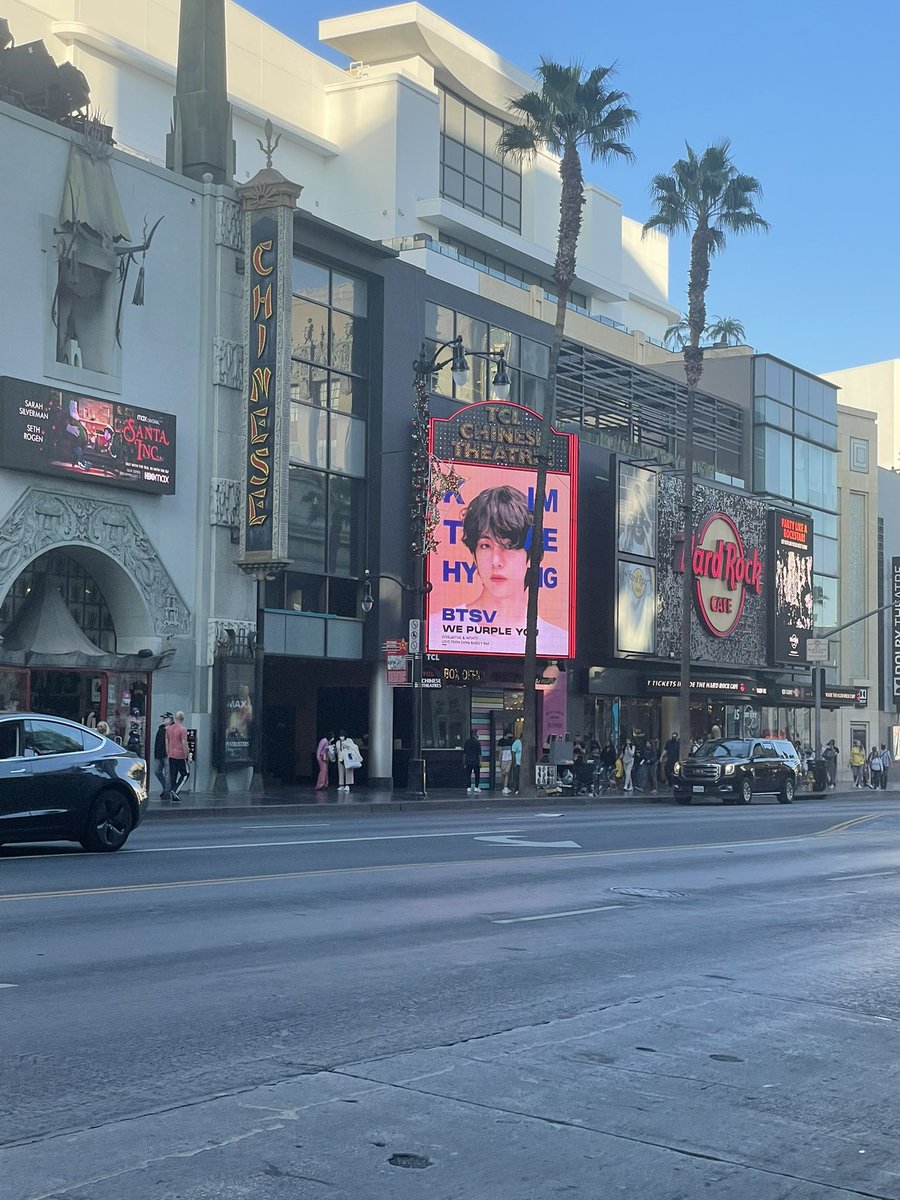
0;487;191;637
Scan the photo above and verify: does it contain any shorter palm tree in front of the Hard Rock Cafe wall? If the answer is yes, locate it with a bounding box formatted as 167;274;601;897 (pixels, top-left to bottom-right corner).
643;138;769;746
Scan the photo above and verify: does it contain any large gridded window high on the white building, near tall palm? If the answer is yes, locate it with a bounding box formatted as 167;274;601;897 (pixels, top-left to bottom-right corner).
440;90;522;233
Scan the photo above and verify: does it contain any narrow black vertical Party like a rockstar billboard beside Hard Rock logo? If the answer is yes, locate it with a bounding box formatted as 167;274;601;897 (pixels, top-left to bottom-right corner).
769;509;815;665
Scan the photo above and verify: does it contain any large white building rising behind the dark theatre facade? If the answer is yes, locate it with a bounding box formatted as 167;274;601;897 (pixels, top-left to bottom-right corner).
6;0;677;362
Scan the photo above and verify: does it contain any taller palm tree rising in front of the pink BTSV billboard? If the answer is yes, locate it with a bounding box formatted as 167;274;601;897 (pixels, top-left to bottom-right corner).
498;59;637;790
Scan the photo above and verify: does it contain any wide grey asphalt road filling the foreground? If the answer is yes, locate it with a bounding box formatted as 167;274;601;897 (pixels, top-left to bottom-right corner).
0;797;900;1200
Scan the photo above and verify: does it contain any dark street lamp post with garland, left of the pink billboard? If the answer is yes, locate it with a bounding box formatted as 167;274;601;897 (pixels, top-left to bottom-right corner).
398;334;510;800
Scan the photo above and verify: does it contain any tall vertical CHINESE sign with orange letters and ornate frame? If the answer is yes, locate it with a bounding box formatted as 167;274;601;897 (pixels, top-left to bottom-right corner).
238;167;302;578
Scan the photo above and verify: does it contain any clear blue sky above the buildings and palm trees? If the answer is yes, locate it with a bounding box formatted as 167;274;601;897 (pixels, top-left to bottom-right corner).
236;0;900;372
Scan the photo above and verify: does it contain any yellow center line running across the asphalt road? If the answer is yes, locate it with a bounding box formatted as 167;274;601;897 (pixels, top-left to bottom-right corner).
0;812;887;904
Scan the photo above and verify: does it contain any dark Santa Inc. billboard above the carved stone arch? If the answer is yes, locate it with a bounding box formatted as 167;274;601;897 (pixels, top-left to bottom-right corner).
0;378;175;496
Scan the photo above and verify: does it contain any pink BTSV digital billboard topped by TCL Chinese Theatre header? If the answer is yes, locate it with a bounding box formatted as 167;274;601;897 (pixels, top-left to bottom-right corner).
426;402;577;659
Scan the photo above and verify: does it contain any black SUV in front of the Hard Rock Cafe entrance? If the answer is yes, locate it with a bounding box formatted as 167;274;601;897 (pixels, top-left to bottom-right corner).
673;738;800;804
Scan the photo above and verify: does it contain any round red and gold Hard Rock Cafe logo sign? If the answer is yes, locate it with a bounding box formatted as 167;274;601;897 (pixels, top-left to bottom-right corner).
680;512;762;637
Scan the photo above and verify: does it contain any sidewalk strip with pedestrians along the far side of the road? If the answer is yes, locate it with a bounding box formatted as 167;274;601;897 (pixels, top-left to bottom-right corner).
144;784;900;821
